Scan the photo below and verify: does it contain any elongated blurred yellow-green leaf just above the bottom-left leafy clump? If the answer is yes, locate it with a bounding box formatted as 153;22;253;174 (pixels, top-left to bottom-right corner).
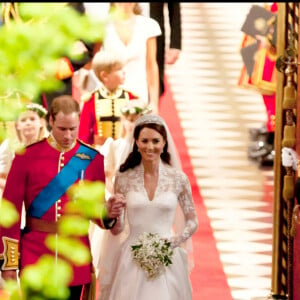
45;235;91;266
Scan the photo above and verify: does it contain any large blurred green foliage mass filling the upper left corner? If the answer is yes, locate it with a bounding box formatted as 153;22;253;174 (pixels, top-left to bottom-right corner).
0;2;103;108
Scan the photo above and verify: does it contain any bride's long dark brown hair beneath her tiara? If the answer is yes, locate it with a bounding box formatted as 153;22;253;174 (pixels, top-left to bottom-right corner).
120;123;170;172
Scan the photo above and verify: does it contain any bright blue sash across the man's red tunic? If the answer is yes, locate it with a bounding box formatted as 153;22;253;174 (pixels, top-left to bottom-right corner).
27;145;97;218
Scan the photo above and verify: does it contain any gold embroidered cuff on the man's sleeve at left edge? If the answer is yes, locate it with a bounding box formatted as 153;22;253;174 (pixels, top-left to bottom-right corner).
2;237;20;271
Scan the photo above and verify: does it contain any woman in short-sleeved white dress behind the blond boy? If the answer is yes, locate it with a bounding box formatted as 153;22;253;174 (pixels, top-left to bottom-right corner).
102;2;161;113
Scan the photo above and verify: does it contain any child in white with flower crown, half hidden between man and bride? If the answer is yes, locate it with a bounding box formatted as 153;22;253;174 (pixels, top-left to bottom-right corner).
90;99;150;278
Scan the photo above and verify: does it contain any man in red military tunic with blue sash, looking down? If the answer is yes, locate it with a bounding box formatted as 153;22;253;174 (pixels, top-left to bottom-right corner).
0;95;124;300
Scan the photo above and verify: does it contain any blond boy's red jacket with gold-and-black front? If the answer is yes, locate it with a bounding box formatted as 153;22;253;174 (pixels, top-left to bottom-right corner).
79;86;137;145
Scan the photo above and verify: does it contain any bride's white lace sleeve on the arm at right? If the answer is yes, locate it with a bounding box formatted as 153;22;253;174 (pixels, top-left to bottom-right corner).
171;173;198;248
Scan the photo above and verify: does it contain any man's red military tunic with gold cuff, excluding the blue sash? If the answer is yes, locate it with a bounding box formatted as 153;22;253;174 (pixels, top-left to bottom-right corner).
0;136;105;285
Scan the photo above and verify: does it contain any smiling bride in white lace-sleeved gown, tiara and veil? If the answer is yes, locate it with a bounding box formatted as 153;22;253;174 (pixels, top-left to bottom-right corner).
100;114;198;300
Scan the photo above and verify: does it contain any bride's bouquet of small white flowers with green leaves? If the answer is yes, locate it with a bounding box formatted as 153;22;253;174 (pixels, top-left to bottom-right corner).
131;232;173;279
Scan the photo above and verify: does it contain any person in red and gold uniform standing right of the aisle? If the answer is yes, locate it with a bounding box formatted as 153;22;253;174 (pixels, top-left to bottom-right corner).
238;3;277;165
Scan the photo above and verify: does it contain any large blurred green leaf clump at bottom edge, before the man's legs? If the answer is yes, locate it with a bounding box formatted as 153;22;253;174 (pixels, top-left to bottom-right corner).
20;255;72;300
